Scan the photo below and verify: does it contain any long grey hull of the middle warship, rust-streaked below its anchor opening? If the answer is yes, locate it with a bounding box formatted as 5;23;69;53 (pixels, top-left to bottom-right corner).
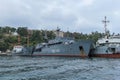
32;40;94;57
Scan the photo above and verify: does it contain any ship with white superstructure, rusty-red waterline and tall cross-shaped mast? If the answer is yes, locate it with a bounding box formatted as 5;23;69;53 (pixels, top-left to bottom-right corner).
93;16;120;58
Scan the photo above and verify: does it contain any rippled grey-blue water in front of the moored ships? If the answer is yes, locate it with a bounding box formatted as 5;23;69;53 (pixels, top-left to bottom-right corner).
0;56;120;80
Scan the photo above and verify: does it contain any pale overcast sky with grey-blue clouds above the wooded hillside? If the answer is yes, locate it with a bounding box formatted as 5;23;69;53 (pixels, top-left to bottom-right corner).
0;0;120;33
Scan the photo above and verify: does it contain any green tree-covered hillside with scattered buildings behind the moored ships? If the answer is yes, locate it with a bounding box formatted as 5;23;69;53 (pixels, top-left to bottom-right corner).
0;26;104;52
